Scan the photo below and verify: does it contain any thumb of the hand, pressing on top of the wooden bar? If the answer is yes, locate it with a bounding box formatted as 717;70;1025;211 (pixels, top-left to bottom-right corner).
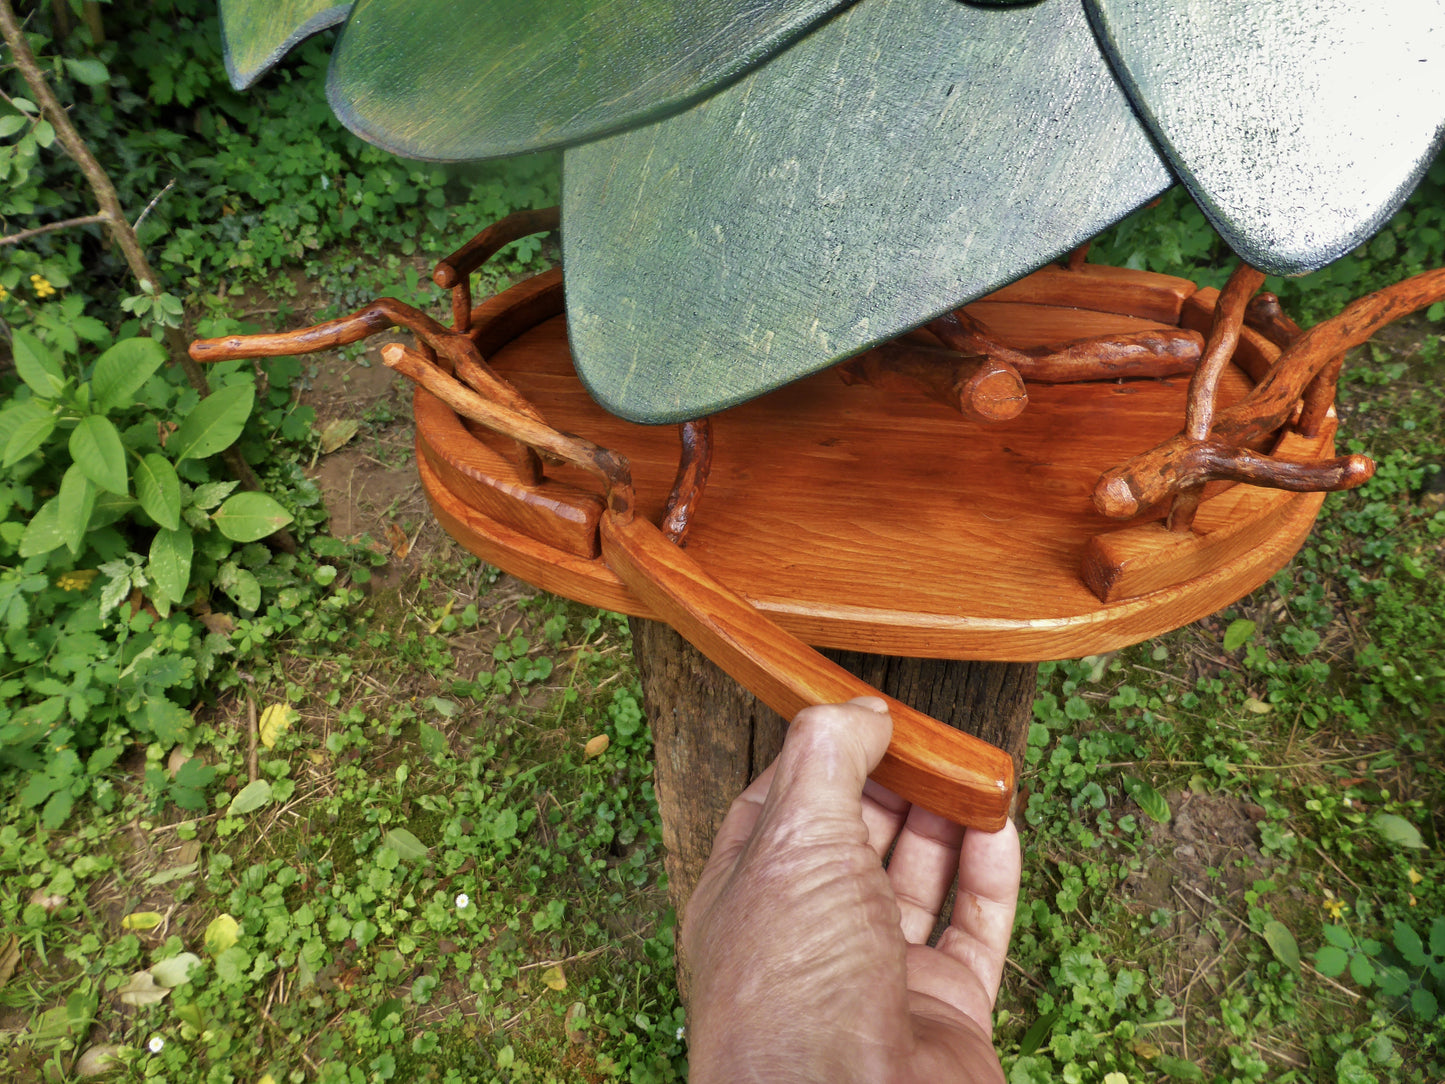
762;697;893;824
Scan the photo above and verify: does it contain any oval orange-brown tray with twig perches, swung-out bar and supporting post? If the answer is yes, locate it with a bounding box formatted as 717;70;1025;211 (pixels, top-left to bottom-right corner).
192;212;1445;919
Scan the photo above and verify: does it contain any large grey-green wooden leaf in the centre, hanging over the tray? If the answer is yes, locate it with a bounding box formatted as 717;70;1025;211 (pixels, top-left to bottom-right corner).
562;0;1169;422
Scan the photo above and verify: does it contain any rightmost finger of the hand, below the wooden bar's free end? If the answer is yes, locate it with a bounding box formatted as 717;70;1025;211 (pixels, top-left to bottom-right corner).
938;821;1020;1005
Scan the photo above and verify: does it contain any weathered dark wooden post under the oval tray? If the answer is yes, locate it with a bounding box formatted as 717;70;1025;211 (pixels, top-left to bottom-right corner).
631;617;1039;999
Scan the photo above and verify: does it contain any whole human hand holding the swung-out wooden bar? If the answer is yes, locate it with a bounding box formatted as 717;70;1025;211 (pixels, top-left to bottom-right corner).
682;697;1019;1084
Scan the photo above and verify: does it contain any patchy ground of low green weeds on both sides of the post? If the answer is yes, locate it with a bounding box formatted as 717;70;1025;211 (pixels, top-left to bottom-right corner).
0;307;1445;1084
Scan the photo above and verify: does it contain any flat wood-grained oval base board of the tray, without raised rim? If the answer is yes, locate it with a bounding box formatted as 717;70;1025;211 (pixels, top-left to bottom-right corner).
418;270;1331;661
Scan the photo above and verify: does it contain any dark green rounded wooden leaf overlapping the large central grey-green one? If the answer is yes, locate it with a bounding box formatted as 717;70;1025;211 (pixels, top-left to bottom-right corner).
327;0;850;160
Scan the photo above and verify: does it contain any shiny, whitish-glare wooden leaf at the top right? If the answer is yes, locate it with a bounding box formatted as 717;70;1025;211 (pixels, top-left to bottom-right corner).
1085;0;1445;275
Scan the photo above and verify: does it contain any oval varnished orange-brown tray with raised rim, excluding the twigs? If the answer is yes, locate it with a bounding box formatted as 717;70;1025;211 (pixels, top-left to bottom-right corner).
415;266;1334;662
